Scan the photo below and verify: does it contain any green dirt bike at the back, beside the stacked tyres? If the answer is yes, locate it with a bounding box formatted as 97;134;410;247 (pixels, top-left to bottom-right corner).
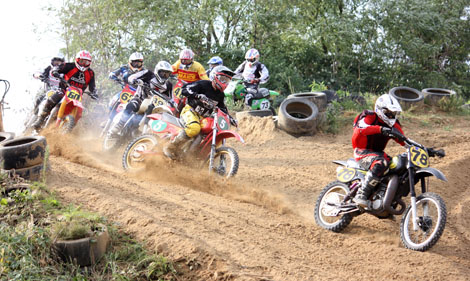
224;76;279;115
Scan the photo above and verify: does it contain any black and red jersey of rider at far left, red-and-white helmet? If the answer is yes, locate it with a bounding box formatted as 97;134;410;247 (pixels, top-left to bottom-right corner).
52;62;95;93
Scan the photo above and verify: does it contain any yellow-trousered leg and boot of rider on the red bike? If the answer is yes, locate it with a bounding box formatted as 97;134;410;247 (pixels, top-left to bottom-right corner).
163;105;201;159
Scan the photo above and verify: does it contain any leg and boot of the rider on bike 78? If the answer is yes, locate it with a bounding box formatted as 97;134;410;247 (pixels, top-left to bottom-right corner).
353;155;388;208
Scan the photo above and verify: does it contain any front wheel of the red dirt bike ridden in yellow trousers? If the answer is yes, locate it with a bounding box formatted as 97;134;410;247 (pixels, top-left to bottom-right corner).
205;147;240;178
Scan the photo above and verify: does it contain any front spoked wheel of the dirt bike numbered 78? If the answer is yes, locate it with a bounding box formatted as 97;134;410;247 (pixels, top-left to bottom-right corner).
400;192;447;252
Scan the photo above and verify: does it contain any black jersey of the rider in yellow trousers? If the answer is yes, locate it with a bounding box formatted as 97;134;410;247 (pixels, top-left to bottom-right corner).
181;80;228;117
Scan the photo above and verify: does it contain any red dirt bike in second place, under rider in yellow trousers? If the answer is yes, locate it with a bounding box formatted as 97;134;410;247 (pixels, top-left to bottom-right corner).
122;99;245;178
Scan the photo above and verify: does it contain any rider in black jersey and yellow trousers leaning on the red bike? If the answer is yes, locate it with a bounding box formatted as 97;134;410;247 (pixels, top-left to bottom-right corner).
163;65;237;159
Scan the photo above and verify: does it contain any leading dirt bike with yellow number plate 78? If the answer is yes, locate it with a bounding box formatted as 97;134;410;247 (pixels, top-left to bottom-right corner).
315;134;447;251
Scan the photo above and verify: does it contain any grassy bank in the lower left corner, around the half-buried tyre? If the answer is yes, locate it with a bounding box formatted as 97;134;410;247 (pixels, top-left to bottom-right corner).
0;175;178;280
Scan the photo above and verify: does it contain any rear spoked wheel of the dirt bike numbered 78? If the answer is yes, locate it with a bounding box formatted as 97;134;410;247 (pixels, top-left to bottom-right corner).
315;181;353;232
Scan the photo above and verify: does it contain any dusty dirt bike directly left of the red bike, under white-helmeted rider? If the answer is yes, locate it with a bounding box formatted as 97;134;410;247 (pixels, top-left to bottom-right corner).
103;85;176;151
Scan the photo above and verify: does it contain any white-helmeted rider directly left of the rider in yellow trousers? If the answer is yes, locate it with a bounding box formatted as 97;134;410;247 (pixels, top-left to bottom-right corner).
109;61;176;136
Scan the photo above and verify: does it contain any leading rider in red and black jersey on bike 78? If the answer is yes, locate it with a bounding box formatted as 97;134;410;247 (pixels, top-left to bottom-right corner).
352;94;405;208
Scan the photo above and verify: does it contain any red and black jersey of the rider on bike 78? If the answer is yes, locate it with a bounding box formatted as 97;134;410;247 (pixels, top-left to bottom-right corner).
351;110;405;160
